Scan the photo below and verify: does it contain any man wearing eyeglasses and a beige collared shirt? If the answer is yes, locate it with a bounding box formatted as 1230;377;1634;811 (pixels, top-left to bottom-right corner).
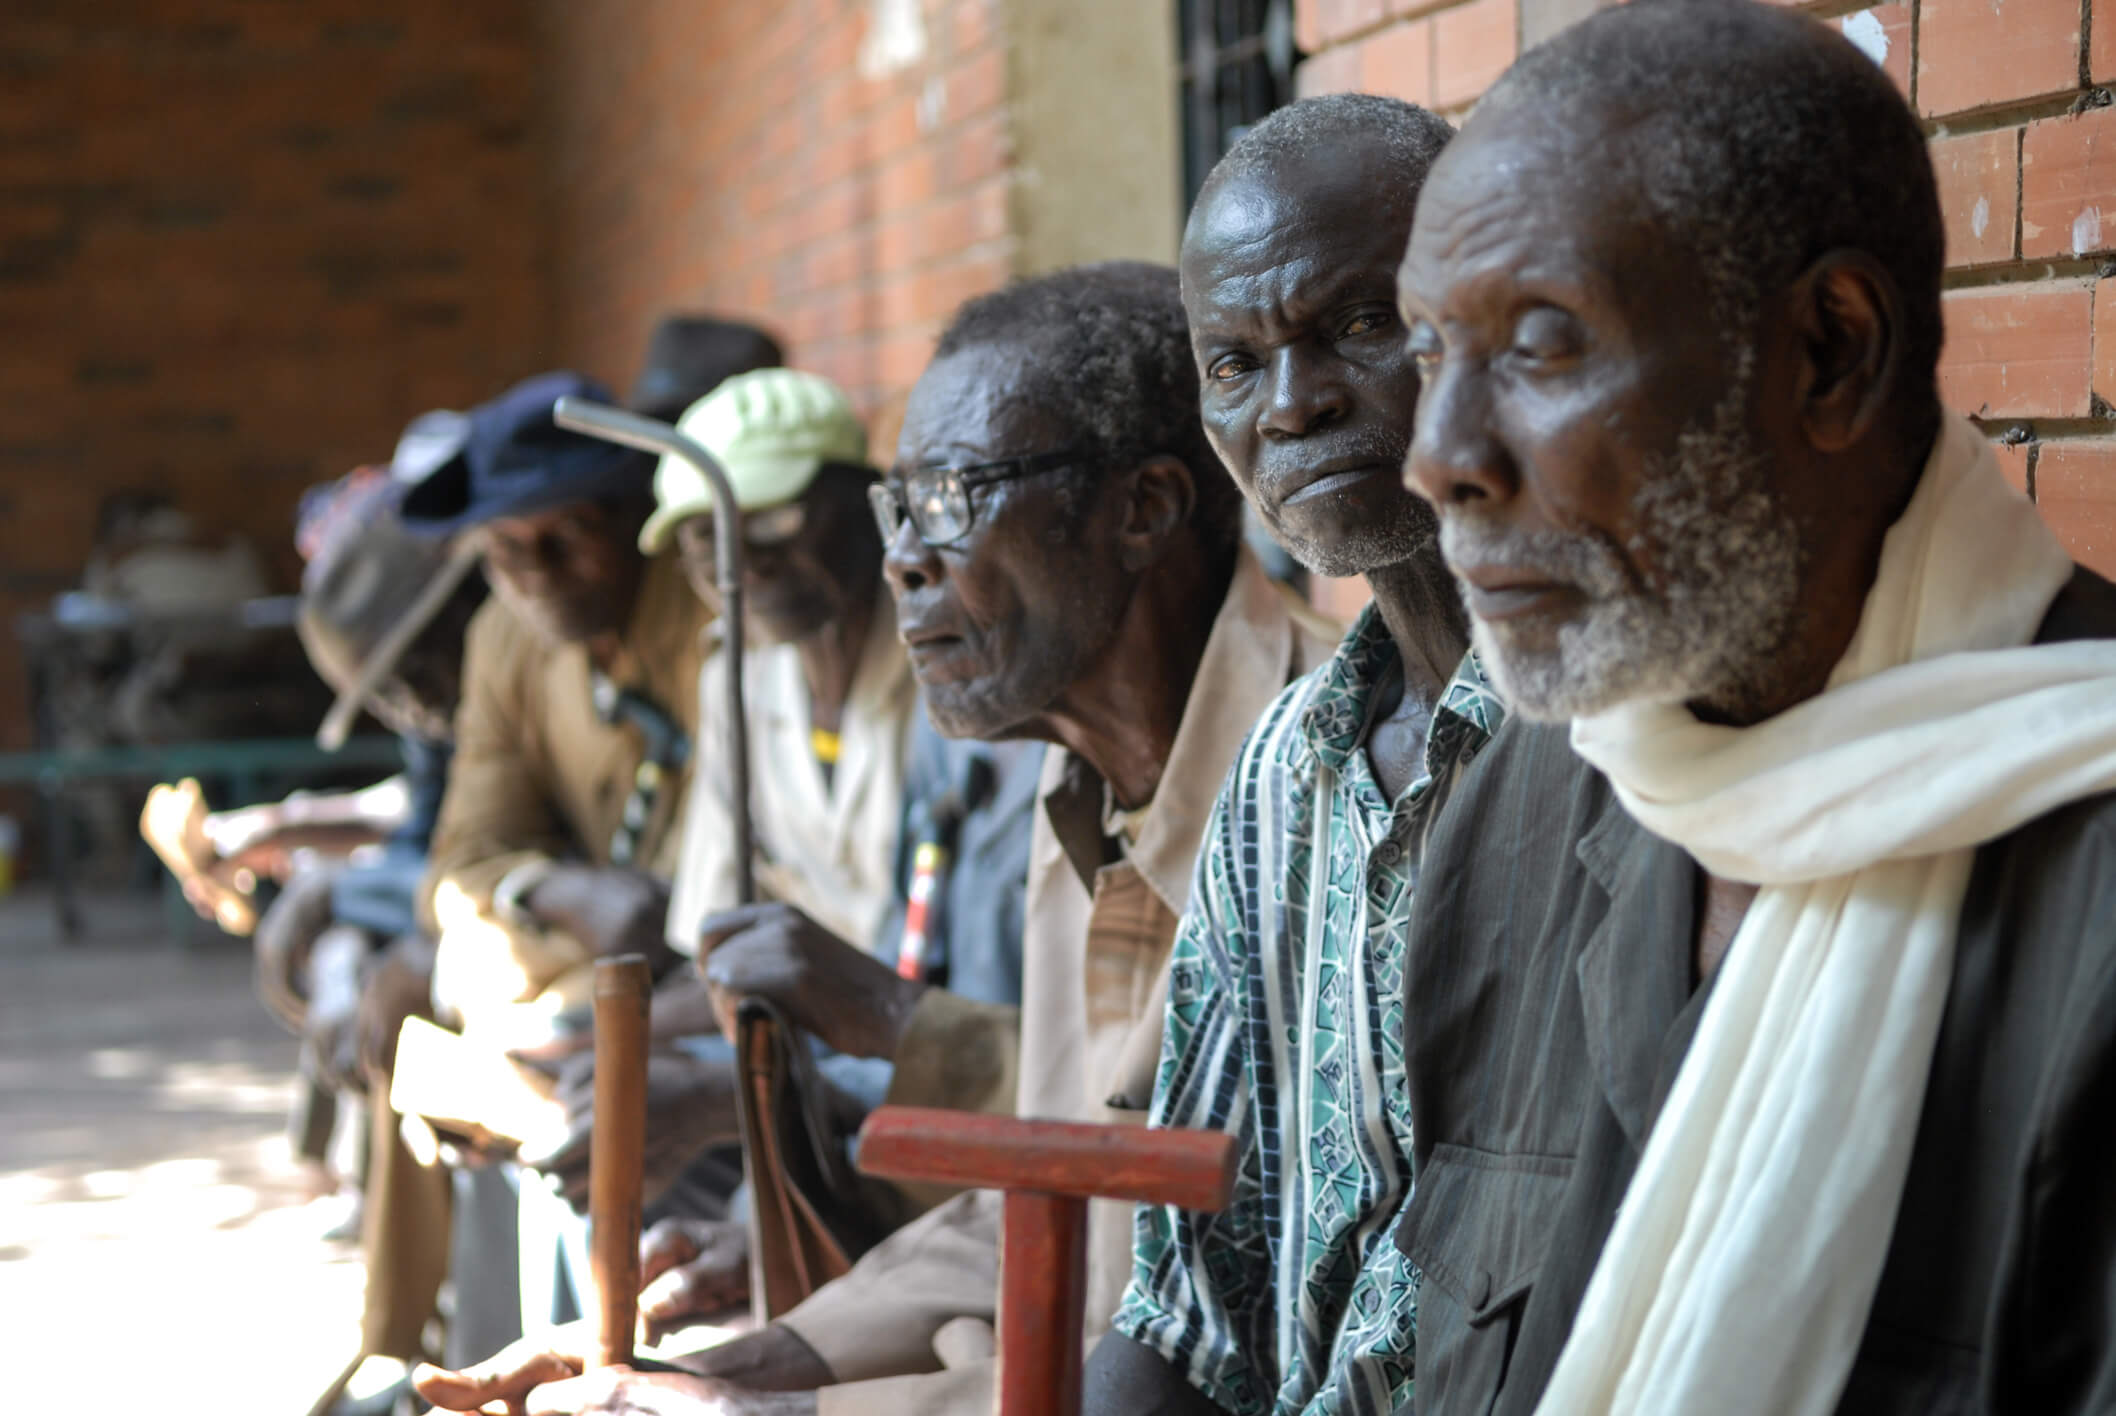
421;262;1335;1416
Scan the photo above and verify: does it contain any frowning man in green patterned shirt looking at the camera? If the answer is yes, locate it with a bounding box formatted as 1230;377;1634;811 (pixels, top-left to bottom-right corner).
1088;95;1502;1416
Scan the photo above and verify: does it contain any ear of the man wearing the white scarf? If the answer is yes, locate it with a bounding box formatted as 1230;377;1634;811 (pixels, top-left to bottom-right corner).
1790;250;1902;453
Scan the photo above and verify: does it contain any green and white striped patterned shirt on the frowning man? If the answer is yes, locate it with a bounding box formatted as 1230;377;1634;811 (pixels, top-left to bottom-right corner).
1115;605;1504;1416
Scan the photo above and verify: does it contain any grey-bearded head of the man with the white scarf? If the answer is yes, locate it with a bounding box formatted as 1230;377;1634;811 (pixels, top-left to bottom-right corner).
1401;0;1942;722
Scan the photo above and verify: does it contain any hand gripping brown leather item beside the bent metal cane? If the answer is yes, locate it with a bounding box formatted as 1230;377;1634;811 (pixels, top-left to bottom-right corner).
698;904;927;1058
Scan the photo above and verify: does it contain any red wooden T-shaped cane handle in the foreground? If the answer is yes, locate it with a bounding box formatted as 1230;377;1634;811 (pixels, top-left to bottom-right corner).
859;1107;1234;1416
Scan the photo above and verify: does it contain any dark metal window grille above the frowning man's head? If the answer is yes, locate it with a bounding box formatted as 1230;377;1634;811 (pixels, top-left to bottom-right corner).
1176;0;1299;210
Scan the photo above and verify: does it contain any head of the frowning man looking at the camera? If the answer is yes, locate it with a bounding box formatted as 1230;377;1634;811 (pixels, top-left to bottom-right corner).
1181;93;1454;576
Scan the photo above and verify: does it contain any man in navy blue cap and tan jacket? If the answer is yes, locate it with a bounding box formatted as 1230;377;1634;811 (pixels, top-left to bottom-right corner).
404;375;705;1043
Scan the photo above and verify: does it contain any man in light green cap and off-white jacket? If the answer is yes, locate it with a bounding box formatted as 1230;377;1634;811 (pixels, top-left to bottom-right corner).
655;368;916;973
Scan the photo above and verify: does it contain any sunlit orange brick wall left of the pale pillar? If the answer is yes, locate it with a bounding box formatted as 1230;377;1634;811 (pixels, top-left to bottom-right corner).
544;0;1018;447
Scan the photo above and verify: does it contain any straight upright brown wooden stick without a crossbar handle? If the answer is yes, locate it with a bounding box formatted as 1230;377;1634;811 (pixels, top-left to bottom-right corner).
588;955;654;1367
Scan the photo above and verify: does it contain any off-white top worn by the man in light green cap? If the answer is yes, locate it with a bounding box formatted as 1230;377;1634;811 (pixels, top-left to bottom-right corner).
669;584;918;955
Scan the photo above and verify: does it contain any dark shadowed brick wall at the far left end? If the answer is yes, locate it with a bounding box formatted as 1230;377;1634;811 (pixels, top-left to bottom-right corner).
0;0;546;749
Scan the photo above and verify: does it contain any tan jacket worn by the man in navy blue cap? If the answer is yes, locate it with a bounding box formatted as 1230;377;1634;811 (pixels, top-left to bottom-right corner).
421;557;707;1015
